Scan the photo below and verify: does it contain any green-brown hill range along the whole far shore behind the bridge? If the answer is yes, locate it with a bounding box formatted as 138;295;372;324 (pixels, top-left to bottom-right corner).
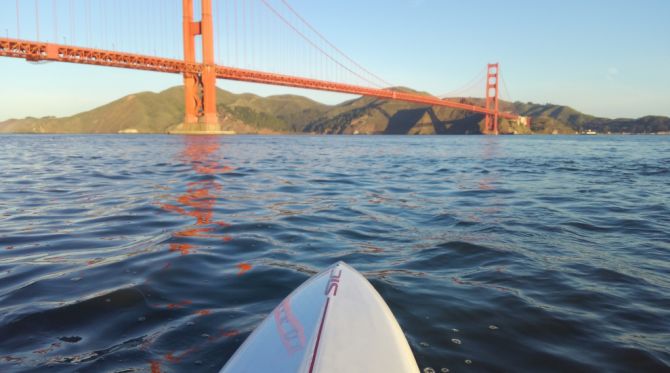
0;87;670;135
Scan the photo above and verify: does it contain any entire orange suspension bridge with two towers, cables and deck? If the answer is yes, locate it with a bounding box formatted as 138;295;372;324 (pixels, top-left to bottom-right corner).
0;0;528;134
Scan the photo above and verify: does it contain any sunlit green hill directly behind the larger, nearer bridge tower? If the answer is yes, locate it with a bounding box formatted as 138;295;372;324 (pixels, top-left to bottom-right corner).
0;87;328;133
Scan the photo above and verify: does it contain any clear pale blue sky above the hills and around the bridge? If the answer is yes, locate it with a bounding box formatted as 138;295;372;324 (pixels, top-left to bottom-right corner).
0;0;670;120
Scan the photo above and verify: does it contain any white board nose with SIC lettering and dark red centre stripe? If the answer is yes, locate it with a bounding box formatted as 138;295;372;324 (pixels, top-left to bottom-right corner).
221;262;419;373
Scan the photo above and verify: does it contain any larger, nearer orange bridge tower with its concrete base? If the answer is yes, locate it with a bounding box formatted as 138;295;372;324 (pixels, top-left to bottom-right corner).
170;0;227;134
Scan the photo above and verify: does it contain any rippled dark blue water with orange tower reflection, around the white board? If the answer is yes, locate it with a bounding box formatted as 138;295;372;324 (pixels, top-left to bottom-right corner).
0;135;670;372
